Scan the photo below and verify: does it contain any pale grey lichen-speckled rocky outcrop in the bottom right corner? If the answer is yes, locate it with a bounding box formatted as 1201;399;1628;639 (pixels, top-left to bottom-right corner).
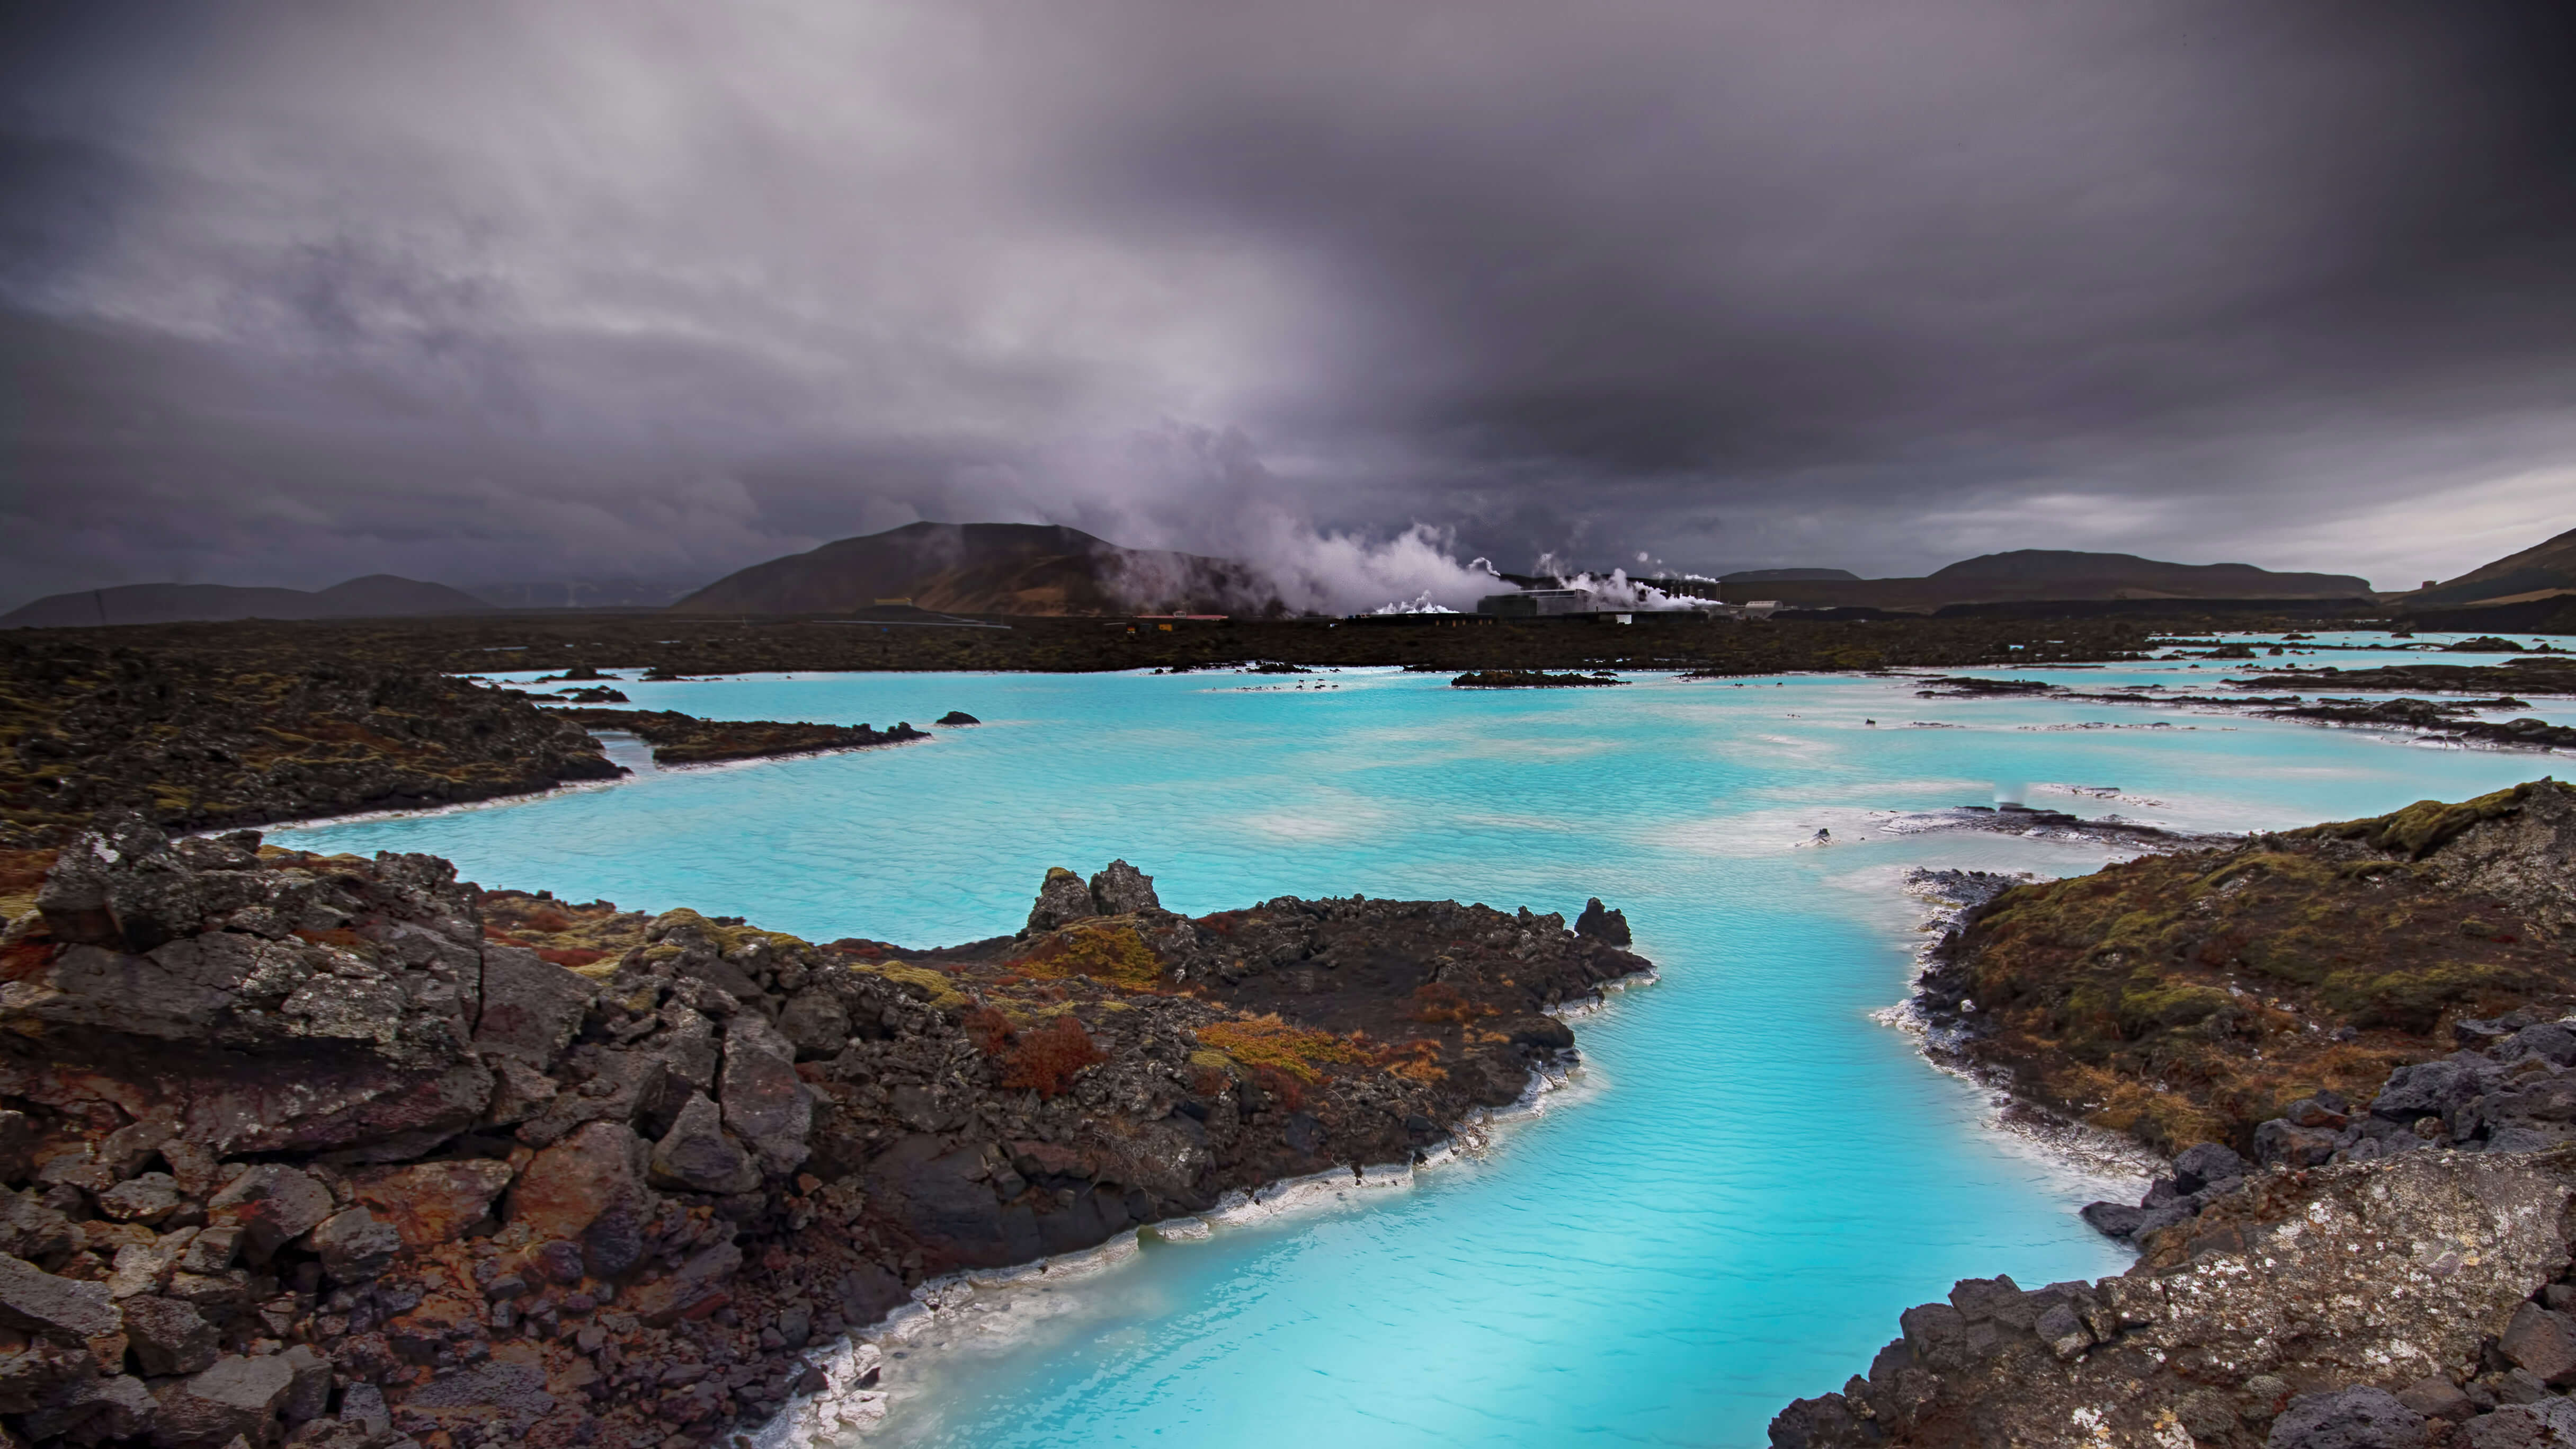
1770;1148;2576;1449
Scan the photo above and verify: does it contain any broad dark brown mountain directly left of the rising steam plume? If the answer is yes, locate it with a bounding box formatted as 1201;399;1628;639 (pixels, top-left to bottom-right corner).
672;523;1278;614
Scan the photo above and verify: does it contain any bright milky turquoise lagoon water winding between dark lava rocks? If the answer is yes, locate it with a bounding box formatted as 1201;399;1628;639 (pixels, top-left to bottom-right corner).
278;644;2563;1449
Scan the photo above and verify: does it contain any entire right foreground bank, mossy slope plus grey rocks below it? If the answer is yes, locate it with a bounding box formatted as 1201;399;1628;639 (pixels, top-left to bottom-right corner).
1770;779;2576;1449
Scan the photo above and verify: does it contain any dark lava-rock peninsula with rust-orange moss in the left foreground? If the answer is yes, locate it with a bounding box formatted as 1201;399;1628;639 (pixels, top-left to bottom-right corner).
0;815;1646;1449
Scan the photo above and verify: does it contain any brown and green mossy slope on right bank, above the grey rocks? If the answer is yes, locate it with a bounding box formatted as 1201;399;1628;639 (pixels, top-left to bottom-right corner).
1917;779;2576;1152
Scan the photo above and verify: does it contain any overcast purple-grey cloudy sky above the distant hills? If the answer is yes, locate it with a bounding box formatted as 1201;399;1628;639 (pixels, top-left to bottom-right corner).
0;0;2576;609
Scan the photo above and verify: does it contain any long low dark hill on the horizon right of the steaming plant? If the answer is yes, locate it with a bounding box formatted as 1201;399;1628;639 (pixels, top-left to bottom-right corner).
1728;549;2373;614
